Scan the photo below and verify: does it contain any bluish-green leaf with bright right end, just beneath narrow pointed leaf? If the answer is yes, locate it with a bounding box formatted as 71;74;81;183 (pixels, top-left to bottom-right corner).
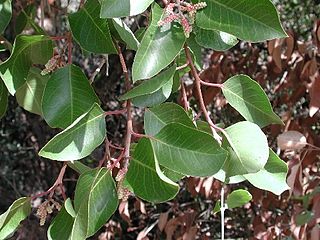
132;78;173;107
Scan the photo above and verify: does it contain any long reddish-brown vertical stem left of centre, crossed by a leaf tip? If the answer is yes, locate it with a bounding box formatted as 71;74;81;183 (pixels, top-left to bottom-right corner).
116;43;133;170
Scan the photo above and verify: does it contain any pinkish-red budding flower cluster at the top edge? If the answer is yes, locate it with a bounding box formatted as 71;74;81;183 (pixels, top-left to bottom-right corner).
158;1;207;38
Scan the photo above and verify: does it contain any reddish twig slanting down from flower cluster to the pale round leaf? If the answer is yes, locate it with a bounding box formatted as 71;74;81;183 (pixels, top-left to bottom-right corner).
184;45;222;144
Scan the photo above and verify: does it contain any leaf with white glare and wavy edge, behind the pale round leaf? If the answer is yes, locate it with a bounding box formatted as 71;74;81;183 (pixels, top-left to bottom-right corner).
244;149;290;195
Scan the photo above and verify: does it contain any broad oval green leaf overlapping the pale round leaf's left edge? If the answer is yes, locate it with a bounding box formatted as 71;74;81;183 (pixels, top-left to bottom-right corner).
151;123;227;177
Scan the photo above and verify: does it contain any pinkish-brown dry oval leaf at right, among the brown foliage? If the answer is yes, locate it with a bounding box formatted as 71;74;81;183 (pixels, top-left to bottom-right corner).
277;131;307;151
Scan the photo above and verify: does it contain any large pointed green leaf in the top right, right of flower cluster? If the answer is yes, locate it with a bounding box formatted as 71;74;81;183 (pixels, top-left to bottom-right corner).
196;0;287;42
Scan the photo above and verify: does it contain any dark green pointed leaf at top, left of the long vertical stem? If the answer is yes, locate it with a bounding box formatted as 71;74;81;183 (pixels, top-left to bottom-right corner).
68;0;117;53
